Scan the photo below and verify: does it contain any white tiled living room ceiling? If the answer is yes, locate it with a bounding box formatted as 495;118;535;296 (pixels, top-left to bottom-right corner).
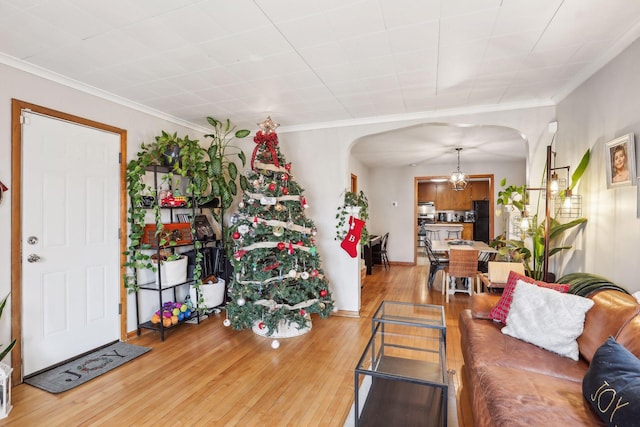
0;0;640;163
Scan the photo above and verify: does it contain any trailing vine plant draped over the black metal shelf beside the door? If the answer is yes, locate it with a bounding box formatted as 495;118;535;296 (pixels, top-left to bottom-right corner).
124;131;209;292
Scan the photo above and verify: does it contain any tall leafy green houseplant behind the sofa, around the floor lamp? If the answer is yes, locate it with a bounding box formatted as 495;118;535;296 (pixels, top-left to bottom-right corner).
492;150;591;280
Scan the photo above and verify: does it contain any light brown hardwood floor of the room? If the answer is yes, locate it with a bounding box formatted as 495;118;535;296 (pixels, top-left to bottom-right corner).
0;265;473;427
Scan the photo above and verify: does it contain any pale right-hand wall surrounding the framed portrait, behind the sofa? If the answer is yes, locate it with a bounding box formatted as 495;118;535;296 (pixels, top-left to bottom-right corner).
554;37;640;292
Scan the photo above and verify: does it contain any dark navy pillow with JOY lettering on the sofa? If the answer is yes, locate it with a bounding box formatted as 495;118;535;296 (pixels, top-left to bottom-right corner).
582;338;640;426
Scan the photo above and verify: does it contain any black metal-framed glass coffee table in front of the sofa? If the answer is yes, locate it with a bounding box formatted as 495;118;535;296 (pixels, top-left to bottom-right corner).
354;301;449;426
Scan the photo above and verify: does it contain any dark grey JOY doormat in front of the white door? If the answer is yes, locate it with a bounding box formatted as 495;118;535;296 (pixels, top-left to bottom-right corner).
24;342;151;393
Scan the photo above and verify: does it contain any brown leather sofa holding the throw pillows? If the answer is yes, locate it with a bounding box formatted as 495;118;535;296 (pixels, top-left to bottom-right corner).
460;290;640;427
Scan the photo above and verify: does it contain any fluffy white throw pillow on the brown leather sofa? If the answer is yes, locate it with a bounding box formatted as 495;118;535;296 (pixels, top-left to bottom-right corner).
502;280;593;360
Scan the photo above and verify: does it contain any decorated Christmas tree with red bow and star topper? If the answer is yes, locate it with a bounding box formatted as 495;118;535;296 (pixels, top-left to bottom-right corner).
225;117;334;344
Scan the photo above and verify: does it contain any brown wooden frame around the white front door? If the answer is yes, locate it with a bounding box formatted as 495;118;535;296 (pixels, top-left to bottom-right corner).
11;99;127;384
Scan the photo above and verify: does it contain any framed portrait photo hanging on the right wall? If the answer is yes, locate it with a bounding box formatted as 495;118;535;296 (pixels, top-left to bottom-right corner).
604;133;636;188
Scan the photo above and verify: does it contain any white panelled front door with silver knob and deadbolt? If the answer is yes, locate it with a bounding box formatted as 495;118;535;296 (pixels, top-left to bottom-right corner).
22;112;120;375
